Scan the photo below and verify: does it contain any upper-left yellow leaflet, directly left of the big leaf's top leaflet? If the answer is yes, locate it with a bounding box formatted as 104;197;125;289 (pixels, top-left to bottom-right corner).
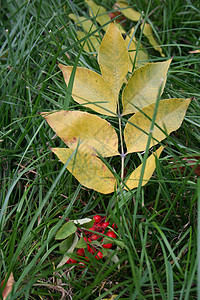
59;64;117;116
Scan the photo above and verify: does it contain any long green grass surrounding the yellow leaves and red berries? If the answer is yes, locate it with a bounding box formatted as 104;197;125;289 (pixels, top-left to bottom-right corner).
0;0;200;299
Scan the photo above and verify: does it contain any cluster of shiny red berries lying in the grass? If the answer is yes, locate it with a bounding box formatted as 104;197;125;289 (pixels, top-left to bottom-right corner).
67;215;117;264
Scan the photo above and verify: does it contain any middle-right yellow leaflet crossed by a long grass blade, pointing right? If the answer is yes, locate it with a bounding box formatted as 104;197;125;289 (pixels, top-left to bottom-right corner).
124;98;191;153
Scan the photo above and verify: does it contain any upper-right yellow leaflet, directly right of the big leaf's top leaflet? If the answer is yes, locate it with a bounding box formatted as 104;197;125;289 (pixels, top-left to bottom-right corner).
122;59;171;115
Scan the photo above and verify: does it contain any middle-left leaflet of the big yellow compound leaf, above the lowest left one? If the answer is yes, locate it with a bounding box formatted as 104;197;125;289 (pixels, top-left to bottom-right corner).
43;110;119;157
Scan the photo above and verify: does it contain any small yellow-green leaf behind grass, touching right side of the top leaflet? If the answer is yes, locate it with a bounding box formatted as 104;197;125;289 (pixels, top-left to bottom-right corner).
125;28;149;73
